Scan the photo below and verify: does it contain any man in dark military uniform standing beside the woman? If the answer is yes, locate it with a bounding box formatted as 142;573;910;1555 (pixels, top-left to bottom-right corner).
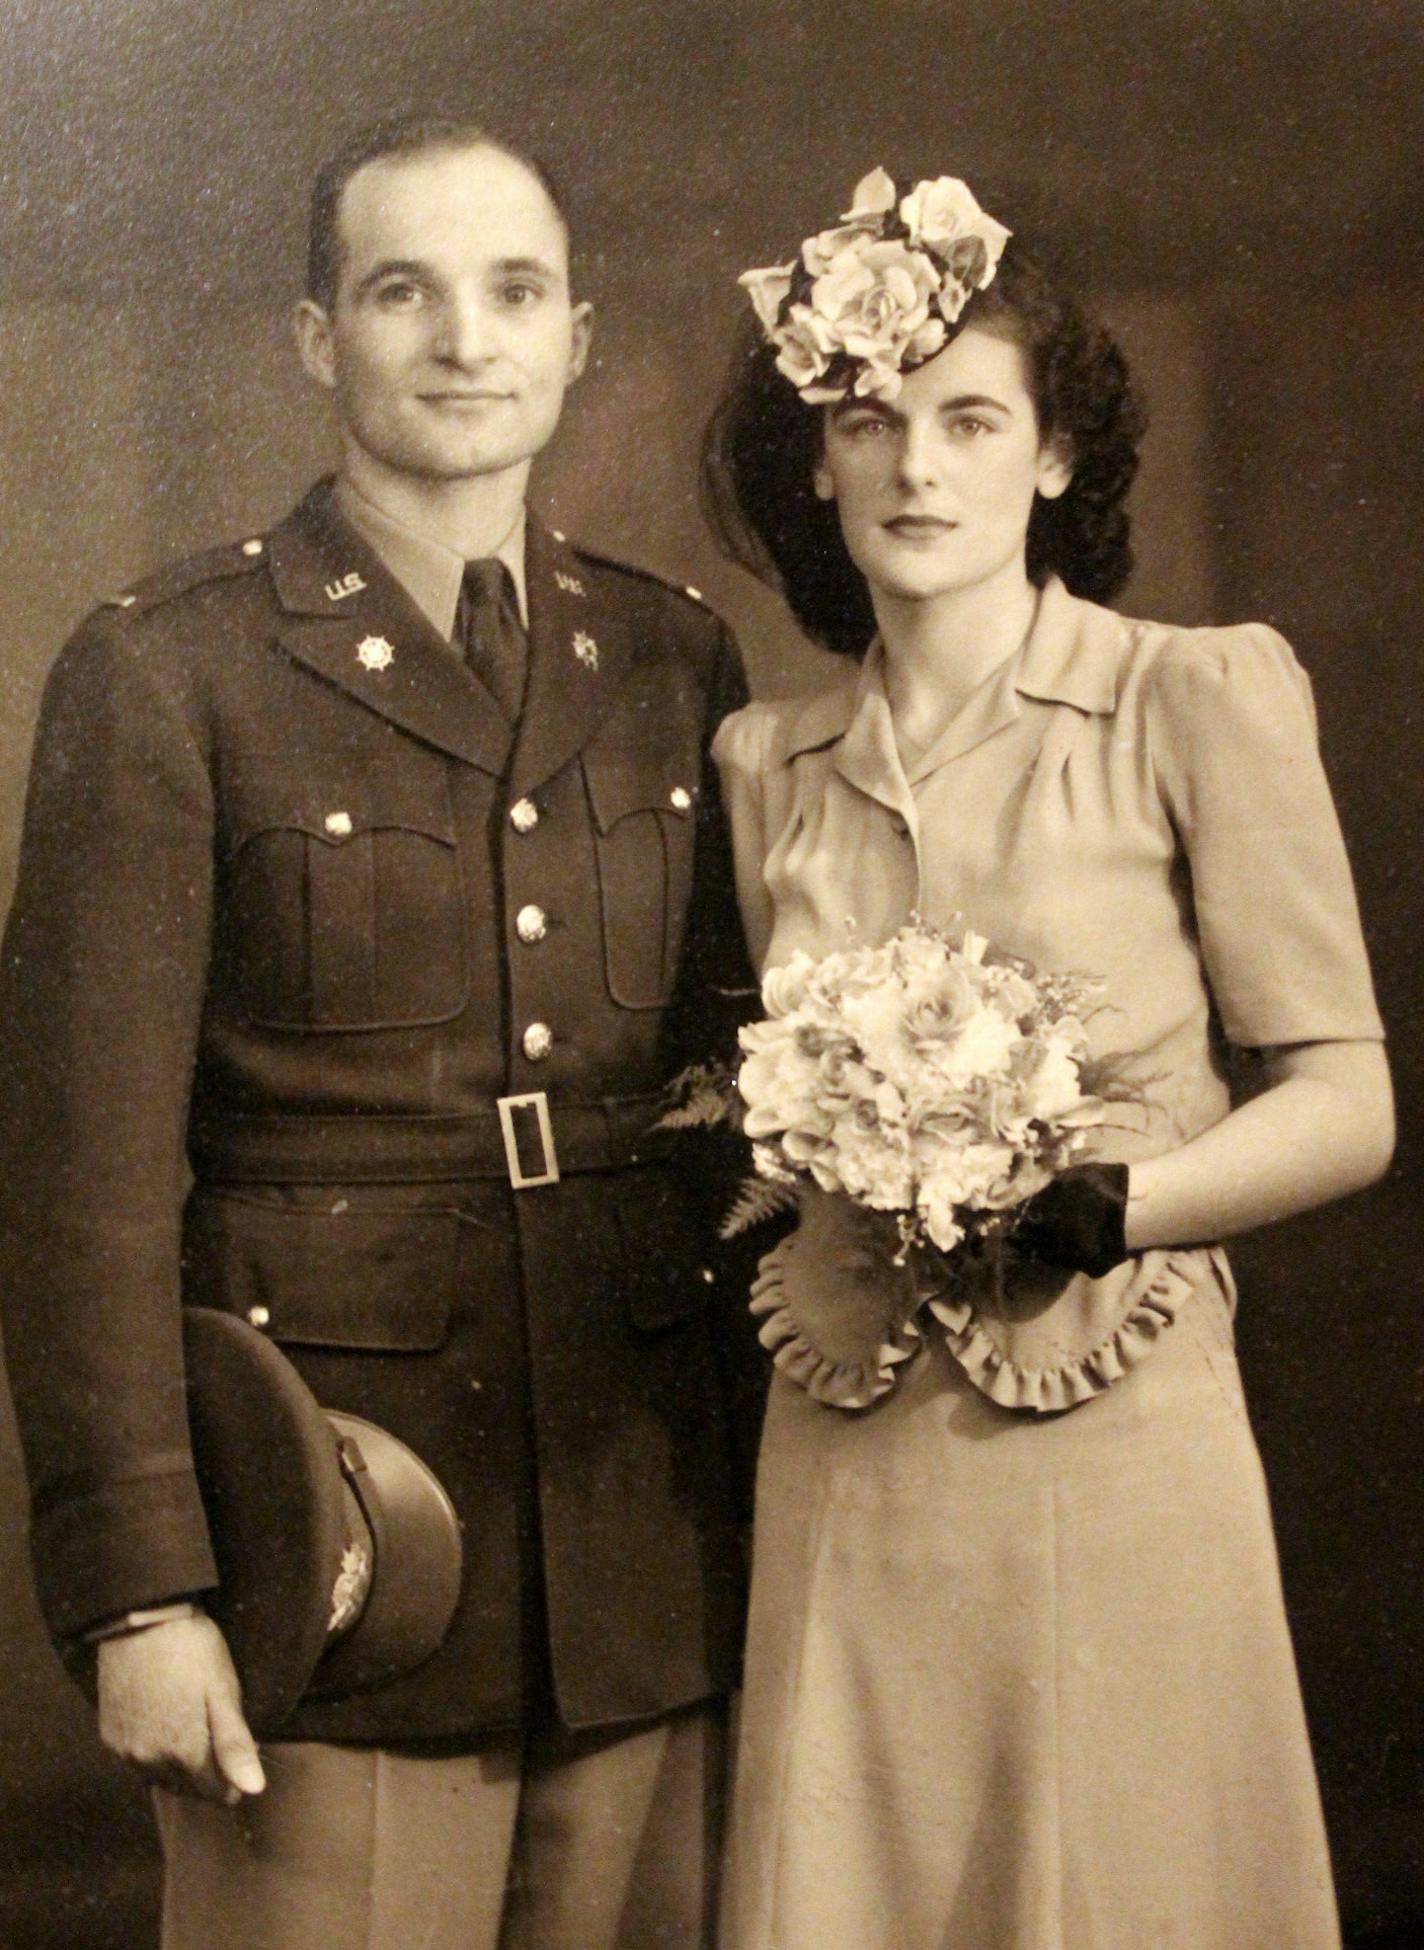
0;123;760;1950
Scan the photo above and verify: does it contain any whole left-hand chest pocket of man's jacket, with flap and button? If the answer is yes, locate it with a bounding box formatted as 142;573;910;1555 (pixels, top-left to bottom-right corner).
222;757;468;1032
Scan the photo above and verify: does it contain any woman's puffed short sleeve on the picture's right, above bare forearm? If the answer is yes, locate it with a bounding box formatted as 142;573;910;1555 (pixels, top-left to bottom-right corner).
1145;624;1383;1047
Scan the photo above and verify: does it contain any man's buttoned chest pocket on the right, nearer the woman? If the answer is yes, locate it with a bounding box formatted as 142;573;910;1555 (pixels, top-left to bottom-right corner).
583;751;698;1008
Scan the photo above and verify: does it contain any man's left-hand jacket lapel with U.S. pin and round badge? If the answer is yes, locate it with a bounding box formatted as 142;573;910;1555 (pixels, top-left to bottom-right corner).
269;484;513;774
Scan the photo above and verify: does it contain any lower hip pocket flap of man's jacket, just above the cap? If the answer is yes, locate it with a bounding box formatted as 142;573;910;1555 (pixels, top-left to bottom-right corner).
183;1193;460;1353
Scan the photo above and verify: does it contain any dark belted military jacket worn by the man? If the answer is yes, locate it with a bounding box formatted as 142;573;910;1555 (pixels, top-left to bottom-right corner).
0;486;749;1739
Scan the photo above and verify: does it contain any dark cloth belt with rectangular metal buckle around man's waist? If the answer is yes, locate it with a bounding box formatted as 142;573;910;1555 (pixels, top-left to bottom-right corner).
189;1090;673;1190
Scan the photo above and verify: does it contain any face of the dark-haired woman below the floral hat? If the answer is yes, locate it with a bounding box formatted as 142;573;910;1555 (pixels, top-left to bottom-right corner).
815;326;1073;603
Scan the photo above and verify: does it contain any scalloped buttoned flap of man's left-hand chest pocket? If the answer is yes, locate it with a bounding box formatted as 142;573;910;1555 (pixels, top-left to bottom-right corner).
224;757;455;852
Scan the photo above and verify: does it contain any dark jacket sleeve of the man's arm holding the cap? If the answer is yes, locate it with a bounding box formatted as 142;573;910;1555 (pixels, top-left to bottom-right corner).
0;612;217;1636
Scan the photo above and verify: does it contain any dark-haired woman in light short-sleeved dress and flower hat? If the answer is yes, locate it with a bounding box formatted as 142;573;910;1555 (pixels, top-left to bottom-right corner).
706;172;1393;1950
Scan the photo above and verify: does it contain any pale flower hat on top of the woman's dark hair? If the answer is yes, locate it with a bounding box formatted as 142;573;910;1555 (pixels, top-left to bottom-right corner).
737;170;1010;406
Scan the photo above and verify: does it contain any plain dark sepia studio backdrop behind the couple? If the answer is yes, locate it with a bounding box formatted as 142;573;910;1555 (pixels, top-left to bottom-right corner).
0;0;1424;1950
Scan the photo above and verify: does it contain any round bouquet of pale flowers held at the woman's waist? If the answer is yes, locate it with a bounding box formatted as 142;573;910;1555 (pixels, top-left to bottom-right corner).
667;922;1112;1262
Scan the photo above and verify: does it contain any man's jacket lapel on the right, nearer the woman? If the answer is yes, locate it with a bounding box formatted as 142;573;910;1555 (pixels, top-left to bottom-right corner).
511;517;634;798
